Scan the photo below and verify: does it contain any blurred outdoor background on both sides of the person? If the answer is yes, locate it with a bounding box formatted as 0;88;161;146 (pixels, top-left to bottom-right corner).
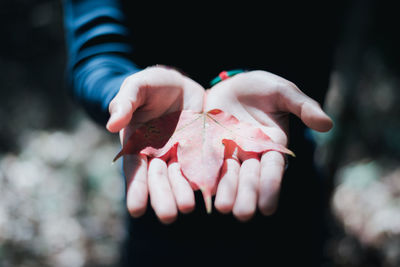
0;0;400;267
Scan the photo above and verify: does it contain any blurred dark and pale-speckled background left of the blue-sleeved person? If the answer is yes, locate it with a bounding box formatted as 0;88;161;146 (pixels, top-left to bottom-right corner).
0;0;125;267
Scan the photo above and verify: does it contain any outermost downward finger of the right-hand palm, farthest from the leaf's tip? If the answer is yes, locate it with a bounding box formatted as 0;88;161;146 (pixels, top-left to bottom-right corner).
258;151;285;215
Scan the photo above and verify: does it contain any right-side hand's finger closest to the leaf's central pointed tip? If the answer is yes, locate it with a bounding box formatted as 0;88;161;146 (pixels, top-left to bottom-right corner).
214;158;240;213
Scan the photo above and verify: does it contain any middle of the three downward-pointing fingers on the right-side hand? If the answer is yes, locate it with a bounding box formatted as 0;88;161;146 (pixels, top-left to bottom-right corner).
233;158;260;221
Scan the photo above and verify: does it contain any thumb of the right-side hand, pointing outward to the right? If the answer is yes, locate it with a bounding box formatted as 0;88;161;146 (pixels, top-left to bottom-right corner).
280;82;333;132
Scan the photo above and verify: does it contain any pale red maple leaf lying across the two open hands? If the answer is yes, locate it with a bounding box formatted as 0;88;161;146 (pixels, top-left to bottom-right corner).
114;109;294;213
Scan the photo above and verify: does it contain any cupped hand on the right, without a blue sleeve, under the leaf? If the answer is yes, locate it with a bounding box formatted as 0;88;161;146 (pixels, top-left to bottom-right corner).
204;71;332;221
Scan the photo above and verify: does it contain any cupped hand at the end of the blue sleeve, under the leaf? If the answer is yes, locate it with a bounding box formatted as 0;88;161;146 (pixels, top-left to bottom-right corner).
107;66;204;223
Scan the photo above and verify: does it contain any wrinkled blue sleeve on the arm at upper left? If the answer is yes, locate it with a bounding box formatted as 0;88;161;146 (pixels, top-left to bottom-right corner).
63;0;139;124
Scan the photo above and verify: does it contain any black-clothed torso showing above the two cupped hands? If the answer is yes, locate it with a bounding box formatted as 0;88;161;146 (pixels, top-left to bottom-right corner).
124;1;341;101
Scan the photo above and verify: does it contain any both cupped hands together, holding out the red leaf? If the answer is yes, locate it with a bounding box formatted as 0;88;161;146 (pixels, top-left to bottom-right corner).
107;67;332;223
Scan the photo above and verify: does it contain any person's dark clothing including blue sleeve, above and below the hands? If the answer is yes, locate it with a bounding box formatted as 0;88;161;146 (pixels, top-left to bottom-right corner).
64;0;341;266
